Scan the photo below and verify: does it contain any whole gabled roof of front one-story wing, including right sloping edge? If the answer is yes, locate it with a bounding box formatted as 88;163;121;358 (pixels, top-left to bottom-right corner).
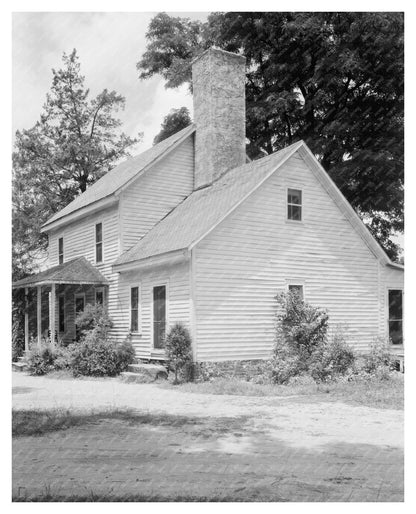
114;141;393;270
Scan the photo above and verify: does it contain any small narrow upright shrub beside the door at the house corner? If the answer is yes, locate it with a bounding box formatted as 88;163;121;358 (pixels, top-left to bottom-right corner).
165;323;192;383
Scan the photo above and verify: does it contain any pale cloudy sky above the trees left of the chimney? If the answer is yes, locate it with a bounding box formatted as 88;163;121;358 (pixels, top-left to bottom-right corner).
12;12;208;153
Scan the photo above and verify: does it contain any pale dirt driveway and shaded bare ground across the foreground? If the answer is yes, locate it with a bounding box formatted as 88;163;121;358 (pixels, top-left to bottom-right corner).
13;373;403;501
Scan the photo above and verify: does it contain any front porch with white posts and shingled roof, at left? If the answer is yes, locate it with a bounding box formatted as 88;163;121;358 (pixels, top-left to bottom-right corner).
13;257;108;351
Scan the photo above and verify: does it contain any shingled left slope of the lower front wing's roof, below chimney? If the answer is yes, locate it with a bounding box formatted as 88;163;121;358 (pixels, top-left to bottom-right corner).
114;142;302;266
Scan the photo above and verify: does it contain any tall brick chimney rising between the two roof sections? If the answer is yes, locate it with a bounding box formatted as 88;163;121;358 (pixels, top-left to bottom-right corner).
192;48;246;189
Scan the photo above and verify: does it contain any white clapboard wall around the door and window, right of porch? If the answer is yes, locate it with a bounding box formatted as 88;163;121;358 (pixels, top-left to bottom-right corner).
117;262;190;359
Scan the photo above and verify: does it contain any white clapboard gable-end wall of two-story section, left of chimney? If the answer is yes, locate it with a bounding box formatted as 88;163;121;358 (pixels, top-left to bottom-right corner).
120;136;194;251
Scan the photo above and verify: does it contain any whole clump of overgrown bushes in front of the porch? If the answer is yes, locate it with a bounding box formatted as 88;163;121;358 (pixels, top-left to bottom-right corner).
27;305;134;377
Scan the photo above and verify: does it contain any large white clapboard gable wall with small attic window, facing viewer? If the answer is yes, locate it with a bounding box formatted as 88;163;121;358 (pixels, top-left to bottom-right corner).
195;154;386;361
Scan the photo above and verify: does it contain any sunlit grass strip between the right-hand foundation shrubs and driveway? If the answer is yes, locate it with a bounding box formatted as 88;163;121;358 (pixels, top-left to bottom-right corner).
159;373;404;410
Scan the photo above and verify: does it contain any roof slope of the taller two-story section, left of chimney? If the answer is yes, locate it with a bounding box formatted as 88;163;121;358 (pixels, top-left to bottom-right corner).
43;125;195;227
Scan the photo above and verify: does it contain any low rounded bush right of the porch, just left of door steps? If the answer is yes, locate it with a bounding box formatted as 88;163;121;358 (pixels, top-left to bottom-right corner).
70;330;134;377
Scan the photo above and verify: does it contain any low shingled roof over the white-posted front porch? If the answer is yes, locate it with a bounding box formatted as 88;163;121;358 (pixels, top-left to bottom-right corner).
13;257;108;289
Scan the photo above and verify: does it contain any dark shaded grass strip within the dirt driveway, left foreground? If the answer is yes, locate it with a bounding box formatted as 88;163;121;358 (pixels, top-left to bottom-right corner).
12;409;246;437
